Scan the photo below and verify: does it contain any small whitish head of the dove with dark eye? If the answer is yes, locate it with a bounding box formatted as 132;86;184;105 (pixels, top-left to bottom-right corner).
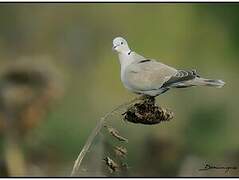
112;37;130;53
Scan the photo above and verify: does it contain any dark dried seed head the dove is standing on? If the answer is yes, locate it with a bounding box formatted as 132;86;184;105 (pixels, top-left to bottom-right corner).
122;97;173;125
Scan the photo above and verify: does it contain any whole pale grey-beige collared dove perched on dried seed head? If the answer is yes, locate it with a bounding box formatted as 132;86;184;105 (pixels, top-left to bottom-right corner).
112;37;225;97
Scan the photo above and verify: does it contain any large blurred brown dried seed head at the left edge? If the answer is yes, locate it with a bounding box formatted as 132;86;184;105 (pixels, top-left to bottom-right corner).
0;57;63;136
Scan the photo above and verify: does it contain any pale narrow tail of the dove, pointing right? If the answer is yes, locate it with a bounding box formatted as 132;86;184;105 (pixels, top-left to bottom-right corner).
192;78;225;88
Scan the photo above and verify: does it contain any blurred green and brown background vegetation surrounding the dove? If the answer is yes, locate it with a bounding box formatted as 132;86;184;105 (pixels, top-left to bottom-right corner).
0;3;239;176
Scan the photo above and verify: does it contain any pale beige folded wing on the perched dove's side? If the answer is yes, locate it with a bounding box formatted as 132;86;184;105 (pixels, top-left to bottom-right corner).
125;59;178;91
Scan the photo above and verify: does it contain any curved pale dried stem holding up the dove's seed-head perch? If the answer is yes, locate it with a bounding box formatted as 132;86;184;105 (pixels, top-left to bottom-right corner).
71;96;144;176
